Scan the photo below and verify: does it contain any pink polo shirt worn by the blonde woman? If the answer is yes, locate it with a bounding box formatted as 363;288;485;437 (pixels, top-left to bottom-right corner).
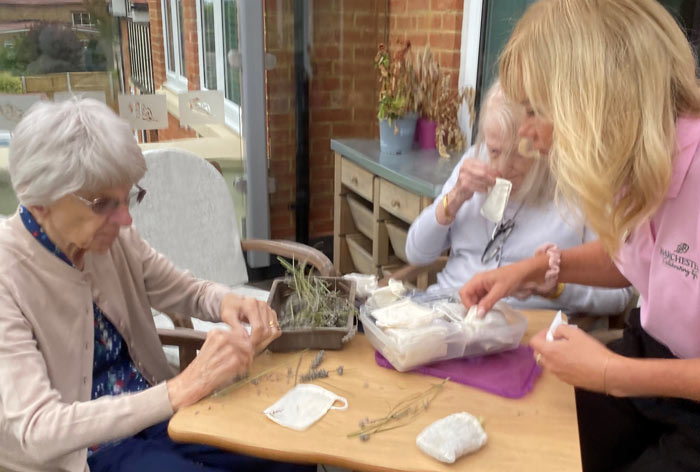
616;118;700;358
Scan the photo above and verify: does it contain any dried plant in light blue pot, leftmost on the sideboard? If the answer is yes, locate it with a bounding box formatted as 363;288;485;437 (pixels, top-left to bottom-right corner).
374;41;418;154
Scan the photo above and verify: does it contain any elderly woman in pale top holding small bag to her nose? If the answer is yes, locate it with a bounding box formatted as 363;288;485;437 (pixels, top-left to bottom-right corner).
406;82;633;315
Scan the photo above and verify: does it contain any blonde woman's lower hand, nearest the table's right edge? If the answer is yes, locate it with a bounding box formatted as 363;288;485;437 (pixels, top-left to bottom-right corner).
530;325;620;393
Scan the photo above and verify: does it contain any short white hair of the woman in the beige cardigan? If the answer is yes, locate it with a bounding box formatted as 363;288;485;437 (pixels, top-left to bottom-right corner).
9;98;146;205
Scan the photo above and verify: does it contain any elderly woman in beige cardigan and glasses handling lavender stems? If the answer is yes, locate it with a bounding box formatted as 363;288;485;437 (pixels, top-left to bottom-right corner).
0;99;315;471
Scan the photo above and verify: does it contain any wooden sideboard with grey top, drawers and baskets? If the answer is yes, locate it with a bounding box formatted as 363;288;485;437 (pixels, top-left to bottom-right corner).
331;139;461;289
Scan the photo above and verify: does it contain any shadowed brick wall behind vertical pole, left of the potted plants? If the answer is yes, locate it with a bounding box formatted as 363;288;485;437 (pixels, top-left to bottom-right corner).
265;0;386;238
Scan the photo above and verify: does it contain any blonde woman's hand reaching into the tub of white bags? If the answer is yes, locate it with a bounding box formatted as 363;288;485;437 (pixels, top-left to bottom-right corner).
459;254;548;318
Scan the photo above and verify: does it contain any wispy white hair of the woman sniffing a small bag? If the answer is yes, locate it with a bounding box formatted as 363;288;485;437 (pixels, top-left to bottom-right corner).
475;80;554;206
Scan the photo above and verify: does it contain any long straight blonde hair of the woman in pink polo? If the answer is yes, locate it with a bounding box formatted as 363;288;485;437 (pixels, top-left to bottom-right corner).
500;0;700;254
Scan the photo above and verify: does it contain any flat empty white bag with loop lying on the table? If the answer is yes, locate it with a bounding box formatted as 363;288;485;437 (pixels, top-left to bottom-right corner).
264;384;348;431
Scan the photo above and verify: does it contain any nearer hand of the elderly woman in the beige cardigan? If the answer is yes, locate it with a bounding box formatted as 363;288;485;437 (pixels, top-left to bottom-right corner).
167;324;255;411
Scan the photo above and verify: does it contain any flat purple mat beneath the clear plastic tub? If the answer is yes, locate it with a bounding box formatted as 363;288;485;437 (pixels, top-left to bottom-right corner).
374;345;542;398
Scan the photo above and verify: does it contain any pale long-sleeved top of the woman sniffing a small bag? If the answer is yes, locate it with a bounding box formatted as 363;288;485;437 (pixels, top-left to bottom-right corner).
406;149;634;315
